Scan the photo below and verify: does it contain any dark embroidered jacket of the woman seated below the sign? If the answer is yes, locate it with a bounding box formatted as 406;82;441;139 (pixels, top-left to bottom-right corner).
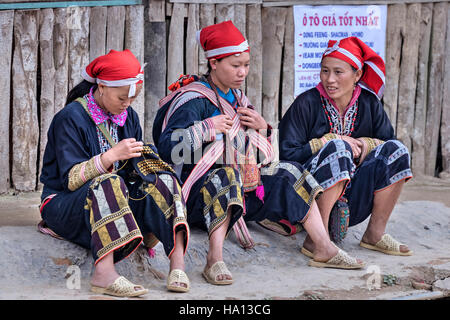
279;88;395;164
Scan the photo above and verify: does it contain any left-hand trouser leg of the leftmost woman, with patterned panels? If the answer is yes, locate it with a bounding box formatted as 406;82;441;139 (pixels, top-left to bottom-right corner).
42;174;142;263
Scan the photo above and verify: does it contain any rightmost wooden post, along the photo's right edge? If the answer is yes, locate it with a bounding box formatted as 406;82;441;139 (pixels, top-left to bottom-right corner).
425;2;448;176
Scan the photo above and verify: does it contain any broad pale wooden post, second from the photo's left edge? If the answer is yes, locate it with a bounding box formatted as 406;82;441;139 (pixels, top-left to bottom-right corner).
11;10;39;191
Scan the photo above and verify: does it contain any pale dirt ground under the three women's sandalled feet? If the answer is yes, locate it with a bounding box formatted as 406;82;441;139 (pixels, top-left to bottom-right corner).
0;178;450;300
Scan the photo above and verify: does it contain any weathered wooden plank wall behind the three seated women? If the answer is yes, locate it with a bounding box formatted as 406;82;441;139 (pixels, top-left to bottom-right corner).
0;0;450;193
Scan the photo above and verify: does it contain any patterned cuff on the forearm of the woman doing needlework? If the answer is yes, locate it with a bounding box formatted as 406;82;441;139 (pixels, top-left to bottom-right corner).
68;154;108;191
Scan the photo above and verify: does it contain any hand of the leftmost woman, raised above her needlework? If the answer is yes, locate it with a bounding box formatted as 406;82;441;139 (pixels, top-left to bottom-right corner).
101;138;144;168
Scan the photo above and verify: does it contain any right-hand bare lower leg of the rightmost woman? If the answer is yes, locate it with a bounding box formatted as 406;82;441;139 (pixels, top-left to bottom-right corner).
362;180;409;252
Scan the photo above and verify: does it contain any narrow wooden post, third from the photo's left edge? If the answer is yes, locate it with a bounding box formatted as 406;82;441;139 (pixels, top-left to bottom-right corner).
38;9;55;186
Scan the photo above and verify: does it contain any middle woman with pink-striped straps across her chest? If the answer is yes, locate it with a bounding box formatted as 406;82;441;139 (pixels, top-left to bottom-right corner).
153;21;363;285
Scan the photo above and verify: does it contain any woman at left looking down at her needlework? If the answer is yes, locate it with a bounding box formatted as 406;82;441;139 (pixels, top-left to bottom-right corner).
39;50;189;296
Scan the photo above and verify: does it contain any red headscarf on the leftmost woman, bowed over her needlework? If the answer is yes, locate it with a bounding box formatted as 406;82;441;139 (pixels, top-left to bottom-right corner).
81;49;144;97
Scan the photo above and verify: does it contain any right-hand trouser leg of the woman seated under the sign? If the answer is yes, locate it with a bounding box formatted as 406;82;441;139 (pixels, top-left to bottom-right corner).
345;140;412;226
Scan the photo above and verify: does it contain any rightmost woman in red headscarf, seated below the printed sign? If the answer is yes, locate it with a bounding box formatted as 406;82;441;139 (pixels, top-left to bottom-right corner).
279;37;412;255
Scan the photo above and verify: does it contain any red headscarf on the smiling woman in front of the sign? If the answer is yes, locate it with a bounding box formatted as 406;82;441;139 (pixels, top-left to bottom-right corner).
322;37;385;99
